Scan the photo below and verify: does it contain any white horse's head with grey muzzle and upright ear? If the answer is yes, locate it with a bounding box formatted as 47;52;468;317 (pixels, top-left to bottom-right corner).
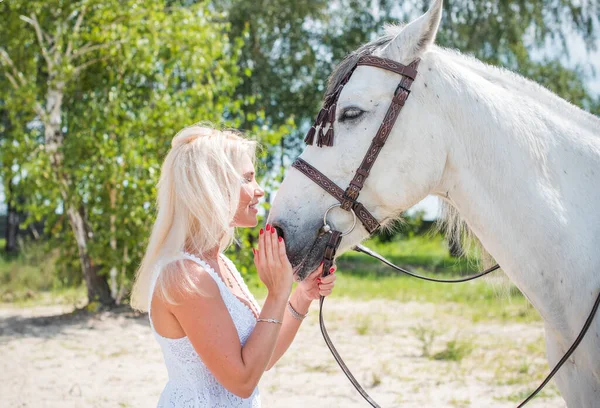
269;0;446;280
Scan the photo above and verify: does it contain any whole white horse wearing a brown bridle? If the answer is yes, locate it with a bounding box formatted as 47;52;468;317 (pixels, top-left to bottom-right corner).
269;0;600;408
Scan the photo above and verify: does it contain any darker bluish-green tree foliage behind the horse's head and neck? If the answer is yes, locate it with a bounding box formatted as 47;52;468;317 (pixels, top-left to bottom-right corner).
213;0;598;150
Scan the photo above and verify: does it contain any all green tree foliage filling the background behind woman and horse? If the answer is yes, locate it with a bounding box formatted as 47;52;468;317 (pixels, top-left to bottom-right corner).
0;0;600;302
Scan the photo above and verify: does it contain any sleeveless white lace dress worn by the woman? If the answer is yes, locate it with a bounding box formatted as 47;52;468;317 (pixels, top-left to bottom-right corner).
148;253;260;408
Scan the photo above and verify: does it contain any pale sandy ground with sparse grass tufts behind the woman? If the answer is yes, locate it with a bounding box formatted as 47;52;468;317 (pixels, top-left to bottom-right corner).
0;299;566;408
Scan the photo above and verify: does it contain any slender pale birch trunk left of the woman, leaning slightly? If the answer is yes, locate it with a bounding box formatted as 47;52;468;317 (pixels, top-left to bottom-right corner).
44;81;114;306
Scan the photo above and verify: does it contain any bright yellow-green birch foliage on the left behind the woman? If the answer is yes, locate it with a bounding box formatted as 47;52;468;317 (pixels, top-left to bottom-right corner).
0;0;268;300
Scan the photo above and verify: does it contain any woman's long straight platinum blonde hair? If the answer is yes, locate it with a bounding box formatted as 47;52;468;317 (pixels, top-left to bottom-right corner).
131;125;256;311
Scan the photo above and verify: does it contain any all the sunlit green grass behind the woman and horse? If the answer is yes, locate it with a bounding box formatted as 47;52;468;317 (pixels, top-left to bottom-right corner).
0;236;539;322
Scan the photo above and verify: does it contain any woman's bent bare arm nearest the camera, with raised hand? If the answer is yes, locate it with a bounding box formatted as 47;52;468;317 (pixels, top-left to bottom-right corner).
171;226;293;398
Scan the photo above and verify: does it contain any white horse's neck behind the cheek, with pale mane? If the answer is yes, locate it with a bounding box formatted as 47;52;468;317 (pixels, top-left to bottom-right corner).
427;48;600;326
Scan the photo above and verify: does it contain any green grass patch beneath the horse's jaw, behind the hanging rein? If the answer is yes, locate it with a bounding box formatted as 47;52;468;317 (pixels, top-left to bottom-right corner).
244;236;540;322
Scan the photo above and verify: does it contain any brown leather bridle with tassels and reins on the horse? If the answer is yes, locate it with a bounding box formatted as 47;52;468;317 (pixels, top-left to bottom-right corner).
292;55;600;408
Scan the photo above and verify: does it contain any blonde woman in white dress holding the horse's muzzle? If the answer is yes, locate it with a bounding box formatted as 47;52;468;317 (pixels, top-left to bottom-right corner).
132;126;335;408
